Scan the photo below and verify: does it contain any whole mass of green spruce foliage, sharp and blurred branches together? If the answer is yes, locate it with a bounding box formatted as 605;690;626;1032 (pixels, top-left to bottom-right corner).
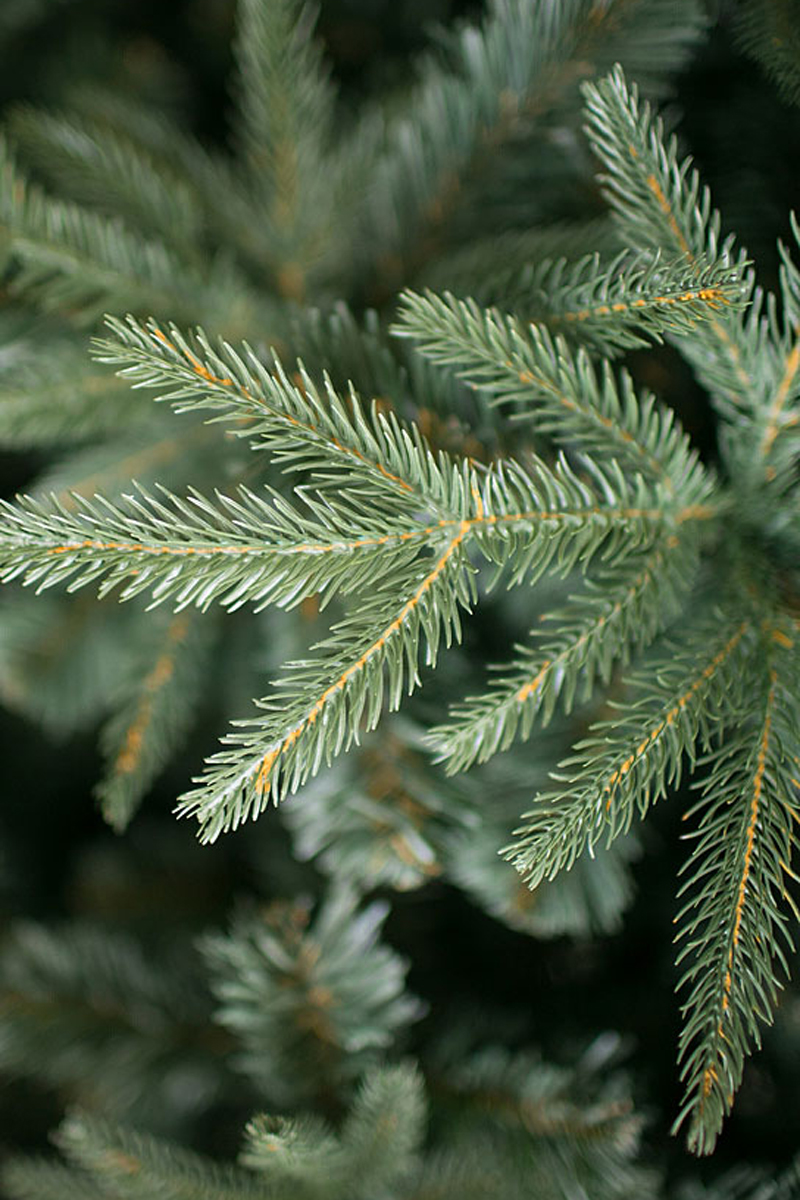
0;0;800;1185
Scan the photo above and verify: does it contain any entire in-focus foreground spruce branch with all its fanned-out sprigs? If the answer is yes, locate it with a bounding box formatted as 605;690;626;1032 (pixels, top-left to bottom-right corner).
0;56;800;1152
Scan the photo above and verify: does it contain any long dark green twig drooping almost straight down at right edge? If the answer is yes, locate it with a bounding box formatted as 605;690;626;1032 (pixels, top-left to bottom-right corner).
675;622;800;1154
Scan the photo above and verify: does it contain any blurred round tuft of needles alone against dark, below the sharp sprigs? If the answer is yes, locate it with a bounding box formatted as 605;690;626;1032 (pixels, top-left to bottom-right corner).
204;888;421;1103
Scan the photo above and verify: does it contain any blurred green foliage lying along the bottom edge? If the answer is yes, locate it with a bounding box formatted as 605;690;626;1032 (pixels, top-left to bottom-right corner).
2;1054;656;1200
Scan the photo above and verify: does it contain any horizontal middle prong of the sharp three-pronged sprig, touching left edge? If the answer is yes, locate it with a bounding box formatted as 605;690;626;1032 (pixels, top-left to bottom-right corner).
0;488;443;611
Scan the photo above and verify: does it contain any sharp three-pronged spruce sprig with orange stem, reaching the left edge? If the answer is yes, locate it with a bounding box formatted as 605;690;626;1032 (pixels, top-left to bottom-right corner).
0;307;715;840
